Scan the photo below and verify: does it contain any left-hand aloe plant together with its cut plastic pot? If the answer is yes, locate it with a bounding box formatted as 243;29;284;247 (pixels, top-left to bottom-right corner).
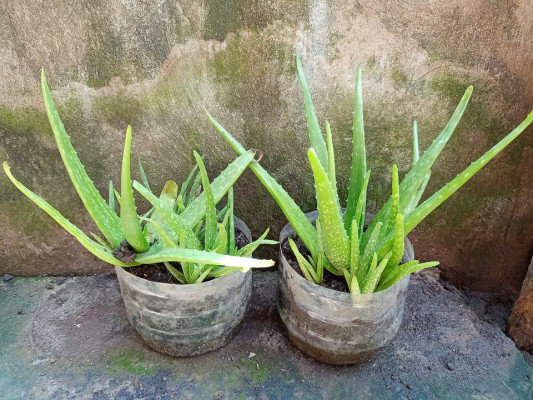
3;71;277;356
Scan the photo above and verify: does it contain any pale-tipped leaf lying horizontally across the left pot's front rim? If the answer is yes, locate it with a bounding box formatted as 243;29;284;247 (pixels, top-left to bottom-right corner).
135;248;274;269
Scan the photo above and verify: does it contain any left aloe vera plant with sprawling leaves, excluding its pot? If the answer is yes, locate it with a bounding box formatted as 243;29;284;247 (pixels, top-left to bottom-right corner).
3;70;277;283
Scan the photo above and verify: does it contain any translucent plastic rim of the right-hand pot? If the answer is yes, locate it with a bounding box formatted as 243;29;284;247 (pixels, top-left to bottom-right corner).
279;210;414;301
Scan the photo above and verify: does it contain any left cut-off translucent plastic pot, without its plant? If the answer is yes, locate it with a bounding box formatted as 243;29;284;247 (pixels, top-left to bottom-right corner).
115;218;252;356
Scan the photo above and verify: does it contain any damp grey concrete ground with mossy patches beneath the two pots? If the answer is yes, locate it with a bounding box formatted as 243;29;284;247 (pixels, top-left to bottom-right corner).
0;271;533;400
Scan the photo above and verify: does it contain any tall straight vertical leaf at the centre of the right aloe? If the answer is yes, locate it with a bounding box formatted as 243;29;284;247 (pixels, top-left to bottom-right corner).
344;67;367;234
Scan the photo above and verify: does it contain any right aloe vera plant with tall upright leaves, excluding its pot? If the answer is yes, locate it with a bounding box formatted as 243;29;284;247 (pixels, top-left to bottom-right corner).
207;59;533;293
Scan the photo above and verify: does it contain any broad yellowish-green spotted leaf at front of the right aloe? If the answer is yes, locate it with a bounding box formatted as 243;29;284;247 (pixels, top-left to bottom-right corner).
307;149;350;271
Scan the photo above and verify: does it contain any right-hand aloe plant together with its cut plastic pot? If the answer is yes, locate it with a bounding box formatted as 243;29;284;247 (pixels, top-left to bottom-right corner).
208;59;533;364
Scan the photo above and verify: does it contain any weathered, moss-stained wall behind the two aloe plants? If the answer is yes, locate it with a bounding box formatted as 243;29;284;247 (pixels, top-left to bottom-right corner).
0;0;533;292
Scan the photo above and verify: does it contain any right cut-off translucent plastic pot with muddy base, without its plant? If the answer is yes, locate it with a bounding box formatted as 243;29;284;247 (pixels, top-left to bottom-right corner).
278;211;414;365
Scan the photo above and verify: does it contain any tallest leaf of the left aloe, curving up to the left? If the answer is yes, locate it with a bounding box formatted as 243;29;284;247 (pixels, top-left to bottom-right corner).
41;69;125;247
